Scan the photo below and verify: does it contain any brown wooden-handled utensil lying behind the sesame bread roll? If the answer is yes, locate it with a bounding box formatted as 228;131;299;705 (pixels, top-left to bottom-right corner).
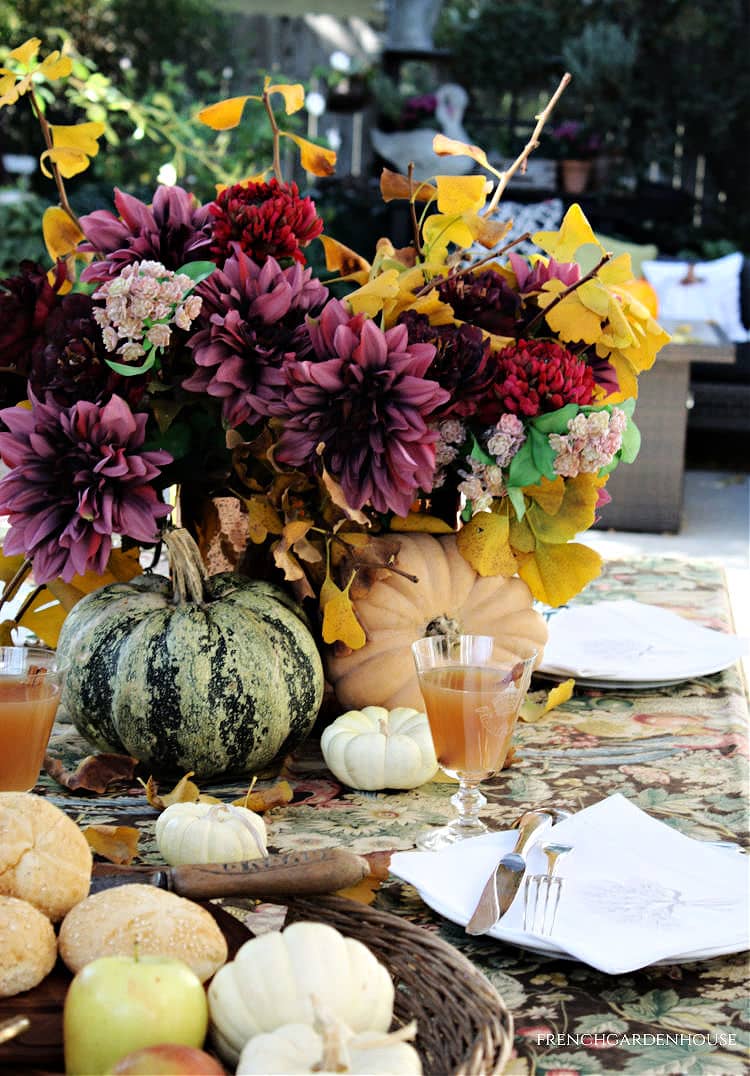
91;848;370;901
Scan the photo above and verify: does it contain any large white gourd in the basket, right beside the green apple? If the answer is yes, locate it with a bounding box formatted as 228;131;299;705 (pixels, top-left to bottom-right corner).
208;922;394;1064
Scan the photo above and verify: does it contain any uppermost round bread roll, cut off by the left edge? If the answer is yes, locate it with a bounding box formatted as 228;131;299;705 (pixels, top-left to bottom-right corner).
0;792;93;923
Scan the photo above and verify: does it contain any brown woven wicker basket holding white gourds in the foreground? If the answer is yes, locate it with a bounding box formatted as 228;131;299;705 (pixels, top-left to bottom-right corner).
286;896;513;1076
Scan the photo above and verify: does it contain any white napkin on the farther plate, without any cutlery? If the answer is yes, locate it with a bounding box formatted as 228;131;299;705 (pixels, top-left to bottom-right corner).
539;600;748;682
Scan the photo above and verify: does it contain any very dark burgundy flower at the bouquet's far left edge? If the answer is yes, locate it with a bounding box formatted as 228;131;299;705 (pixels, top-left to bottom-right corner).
0;261;65;404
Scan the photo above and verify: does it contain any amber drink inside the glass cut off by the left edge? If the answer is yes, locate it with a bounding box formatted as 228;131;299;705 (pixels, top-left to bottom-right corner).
0;676;60;792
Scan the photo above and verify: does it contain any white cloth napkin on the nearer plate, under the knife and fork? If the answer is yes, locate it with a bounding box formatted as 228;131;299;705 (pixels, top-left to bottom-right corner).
391;793;750;975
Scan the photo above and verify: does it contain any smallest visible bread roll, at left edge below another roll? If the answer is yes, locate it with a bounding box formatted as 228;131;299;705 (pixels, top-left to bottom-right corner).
0;896;57;997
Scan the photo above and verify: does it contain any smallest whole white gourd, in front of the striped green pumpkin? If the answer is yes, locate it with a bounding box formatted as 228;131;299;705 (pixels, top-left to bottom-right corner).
156;803;267;866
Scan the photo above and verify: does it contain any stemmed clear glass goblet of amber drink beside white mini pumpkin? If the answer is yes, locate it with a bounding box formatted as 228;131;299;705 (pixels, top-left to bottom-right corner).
411;635;536;851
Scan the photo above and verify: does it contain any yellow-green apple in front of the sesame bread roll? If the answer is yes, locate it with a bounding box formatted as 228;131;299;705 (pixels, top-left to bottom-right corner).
62;957;209;1076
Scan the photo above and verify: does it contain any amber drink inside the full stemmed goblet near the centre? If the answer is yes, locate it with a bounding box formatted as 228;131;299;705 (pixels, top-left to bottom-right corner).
420;665;523;775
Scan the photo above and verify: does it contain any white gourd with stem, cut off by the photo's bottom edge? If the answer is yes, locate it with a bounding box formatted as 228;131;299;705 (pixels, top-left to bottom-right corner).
237;1018;422;1076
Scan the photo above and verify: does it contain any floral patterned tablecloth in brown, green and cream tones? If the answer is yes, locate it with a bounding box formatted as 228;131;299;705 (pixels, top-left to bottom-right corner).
37;558;750;1076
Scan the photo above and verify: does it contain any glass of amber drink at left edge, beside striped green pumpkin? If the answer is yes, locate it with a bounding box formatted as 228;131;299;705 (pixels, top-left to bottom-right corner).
0;647;63;792
